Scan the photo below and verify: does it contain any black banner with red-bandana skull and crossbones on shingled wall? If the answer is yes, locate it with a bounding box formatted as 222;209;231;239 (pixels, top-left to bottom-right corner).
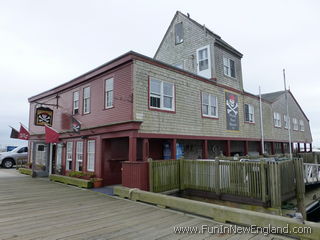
226;92;239;131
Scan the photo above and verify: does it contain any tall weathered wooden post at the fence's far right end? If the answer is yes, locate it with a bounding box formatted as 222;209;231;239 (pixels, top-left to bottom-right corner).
293;158;307;219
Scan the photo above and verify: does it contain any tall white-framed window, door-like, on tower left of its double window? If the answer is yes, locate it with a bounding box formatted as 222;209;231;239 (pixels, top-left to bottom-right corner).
197;45;211;78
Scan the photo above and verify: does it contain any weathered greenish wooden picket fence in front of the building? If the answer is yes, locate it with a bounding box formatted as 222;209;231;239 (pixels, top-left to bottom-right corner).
149;159;304;207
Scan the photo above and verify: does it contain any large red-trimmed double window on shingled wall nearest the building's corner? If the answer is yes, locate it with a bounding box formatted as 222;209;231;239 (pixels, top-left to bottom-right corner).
150;79;174;111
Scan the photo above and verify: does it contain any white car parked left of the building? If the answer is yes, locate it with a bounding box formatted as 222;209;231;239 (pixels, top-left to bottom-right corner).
0;146;28;168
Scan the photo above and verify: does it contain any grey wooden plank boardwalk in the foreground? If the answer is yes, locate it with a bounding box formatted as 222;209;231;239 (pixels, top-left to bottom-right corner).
0;169;289;240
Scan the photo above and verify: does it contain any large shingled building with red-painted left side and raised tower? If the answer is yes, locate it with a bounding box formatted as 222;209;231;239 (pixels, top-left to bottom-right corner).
29;12;312;189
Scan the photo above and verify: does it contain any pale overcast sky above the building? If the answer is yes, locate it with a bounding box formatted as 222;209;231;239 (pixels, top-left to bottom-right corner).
0;0;320;147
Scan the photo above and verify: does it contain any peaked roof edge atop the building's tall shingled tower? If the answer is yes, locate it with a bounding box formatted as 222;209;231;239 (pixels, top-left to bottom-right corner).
154;11;243;58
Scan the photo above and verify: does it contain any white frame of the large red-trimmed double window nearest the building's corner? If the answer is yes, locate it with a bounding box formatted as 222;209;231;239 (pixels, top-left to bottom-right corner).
149;78;175;112
